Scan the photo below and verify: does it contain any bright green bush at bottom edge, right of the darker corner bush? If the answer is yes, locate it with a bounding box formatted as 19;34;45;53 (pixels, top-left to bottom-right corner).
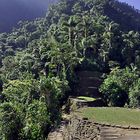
21;100;51;140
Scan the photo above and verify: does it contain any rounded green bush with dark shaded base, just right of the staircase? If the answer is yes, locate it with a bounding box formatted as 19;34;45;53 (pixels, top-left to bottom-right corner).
100;67;139;106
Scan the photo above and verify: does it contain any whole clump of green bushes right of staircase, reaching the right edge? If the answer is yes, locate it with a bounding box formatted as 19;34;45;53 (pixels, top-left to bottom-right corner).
100;67;140;107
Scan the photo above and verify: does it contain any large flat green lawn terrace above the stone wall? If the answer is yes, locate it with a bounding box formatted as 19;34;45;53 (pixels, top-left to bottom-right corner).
80;107;140;126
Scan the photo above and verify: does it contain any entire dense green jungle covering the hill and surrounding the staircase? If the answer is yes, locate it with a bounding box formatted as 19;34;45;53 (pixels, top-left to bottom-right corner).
0;0;140;140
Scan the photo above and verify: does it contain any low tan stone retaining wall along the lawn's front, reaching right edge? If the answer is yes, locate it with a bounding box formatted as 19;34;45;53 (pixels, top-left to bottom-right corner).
63;116;140;140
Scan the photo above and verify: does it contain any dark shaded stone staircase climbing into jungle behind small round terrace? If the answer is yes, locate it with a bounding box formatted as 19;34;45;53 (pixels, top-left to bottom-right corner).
77;71;102;98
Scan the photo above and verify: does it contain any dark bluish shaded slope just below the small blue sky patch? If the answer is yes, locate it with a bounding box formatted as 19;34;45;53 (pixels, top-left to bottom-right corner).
104;0;140;31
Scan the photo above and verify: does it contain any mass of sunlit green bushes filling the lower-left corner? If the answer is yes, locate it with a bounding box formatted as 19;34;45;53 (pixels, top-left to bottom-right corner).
0;79;51;140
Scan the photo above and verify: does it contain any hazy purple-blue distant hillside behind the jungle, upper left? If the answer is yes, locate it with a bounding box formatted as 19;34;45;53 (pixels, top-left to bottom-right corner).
0;0;55;32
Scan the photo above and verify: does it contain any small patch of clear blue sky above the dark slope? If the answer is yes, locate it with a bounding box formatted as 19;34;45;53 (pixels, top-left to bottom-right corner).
119;0;140;10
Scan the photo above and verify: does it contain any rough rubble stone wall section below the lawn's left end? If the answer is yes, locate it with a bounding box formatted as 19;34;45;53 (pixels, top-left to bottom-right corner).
63;116;100;140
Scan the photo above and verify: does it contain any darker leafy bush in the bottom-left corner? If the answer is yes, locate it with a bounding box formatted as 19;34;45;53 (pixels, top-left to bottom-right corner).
0;102;22;140
